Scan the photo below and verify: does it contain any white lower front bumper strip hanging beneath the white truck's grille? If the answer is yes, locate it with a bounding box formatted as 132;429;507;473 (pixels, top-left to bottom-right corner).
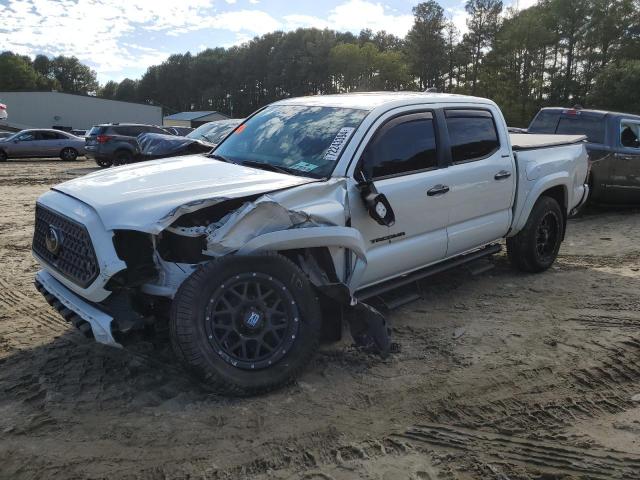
35;270;122;347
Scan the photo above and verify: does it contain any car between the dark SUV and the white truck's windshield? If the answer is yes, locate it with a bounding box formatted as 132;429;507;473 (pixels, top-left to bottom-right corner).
138;118;243;160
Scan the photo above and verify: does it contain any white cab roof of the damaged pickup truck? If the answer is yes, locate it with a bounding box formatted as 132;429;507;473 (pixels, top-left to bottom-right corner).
275;92;494;110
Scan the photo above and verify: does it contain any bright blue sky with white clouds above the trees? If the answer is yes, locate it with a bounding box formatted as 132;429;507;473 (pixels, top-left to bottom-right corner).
0;0;535;83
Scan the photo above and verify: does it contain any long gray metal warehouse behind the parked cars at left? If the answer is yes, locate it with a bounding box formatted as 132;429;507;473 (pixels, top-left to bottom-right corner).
0;92;162;130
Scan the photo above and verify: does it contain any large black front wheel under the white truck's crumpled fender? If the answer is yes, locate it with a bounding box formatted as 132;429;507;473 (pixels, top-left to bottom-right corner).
170;255;321;395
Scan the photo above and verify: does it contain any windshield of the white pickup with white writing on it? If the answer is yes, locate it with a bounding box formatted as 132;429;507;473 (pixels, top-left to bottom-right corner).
214;105;369;178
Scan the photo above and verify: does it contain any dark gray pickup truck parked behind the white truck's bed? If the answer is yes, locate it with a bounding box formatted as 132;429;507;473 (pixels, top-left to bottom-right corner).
527;108;640;204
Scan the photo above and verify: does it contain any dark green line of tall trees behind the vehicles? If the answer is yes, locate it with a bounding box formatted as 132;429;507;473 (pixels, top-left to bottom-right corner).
0;0;640;125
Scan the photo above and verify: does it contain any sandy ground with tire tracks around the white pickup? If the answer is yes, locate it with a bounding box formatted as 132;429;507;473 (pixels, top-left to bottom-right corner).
0;161;640;480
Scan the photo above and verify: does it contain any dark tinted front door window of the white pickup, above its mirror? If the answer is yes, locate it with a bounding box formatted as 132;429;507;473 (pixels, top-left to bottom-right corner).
364;118;438;178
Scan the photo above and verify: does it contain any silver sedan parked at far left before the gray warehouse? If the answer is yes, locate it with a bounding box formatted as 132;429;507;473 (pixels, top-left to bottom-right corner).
0;129;84;162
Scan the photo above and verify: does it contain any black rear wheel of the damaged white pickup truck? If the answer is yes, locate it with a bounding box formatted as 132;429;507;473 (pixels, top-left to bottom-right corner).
507;196;564;273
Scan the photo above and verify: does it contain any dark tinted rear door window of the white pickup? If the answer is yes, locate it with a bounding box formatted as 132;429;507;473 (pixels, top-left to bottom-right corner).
447;112;500;163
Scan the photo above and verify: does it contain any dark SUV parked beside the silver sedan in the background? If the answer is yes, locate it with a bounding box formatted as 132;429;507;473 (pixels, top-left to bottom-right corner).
85;123;167;168
